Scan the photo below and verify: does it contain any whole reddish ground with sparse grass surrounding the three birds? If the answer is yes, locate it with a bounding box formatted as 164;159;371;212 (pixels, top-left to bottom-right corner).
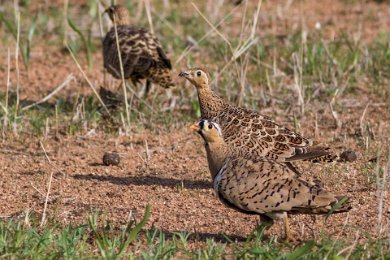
0;0;390;258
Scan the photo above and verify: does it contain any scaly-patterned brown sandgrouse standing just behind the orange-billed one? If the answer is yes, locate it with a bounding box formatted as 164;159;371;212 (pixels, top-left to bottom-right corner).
179;68;329;164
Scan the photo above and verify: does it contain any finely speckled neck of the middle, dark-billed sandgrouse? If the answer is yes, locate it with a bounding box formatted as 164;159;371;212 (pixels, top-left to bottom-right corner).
198;86;227;118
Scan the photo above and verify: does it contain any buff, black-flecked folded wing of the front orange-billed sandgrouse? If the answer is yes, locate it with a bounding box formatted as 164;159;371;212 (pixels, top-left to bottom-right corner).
218;156;348;214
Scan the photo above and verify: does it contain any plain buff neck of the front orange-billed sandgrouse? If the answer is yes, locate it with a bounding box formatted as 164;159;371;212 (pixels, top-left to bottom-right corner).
206;141;228;181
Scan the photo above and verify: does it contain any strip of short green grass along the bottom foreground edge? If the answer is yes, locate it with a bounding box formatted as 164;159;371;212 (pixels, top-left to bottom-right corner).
0;207;390;259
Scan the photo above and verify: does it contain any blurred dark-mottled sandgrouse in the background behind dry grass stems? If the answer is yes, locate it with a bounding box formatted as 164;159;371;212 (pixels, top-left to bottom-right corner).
103;5;174;92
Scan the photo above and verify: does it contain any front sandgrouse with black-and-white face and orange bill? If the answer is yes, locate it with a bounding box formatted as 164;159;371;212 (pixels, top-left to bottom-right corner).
192;120;351;240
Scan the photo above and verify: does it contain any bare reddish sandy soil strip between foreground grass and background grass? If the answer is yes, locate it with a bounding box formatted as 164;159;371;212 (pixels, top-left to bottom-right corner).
0;106;390;244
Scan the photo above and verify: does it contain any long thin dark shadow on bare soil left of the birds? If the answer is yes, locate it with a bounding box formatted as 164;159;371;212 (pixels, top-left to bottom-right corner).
72;174;212;190
